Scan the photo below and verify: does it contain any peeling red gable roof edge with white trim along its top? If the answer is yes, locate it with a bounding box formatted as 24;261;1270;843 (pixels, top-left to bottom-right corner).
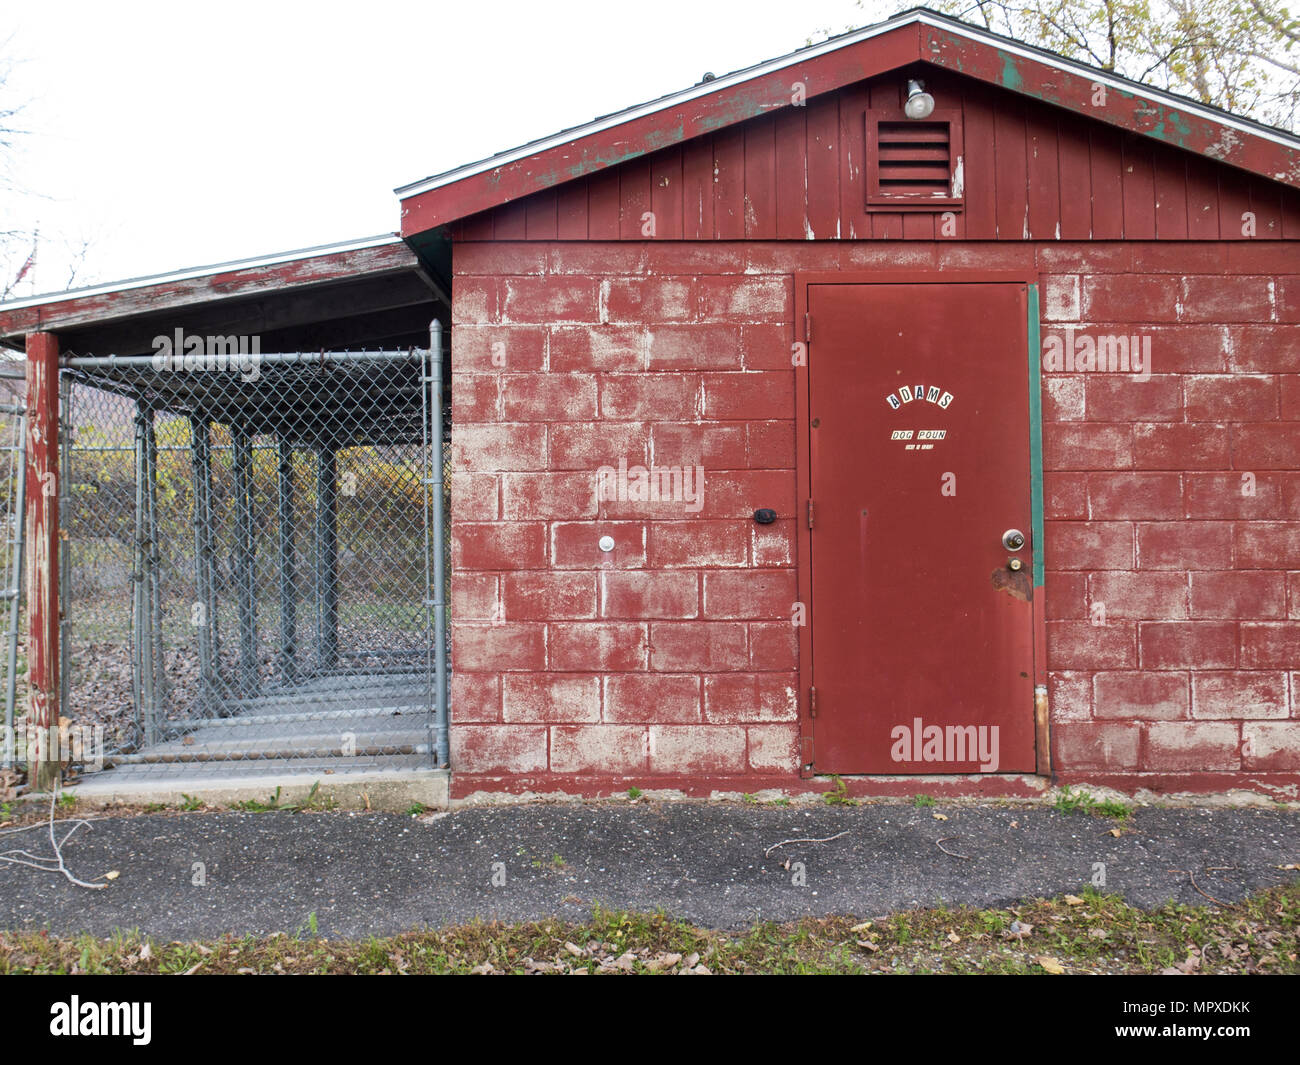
395;8;1300;237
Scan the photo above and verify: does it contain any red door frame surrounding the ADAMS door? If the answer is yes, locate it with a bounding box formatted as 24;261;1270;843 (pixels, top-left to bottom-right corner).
794;270;1052;779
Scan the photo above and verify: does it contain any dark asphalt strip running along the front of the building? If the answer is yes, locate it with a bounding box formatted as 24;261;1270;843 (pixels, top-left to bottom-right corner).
0;802;1300;939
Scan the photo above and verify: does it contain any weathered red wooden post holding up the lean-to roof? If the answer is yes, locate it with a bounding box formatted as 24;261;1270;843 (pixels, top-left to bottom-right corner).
23;333;59;791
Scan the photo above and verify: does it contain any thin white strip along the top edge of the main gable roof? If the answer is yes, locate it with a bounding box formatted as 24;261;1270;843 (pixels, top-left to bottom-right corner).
393;14;1300;199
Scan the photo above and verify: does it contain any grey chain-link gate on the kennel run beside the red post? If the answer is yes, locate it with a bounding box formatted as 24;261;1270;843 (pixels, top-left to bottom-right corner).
60;340;446;779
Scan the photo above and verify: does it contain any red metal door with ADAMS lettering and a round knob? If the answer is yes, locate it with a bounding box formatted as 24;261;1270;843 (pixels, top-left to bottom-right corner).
807;283;1037;774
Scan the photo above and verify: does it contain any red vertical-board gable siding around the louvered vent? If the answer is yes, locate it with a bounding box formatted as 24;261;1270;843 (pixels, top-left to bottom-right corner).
451;70;1300;243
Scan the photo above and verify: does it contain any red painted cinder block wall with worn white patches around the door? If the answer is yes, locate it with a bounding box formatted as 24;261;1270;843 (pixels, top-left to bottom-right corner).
451;242;1300;793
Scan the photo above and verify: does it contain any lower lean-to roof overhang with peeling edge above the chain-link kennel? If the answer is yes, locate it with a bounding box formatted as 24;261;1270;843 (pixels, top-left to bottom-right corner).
0;234;449;355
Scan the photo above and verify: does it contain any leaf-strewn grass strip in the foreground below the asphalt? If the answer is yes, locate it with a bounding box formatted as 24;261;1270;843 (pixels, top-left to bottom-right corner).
0;882;1300;975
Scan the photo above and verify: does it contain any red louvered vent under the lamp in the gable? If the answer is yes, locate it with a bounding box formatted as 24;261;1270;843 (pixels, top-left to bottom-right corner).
866;112;962;211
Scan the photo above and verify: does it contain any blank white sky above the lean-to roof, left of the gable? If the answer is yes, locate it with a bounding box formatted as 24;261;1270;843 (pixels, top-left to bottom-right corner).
0;0;878;295
